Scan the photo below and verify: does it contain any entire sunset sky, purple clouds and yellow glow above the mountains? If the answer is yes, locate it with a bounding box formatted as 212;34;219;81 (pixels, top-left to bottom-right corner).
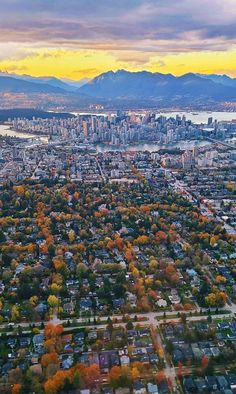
0;0;236;80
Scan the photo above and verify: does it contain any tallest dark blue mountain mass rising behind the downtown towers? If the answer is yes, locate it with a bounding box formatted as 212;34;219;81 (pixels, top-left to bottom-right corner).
78;70;236;103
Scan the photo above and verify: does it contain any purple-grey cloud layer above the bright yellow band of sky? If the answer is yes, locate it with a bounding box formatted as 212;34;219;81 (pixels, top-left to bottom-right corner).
0;0;236;53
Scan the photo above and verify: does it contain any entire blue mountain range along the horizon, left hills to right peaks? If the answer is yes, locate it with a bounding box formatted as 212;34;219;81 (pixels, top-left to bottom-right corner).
0;70;236;106
